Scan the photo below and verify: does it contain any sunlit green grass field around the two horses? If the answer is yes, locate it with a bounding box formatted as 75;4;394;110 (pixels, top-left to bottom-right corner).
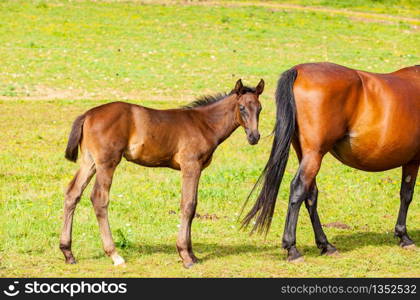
0;0;420;277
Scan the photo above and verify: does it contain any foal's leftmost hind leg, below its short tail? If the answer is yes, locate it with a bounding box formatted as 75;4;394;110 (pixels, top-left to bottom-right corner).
60;152;95;264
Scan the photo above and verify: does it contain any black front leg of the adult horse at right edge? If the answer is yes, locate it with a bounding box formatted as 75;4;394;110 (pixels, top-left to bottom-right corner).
395;161;419;248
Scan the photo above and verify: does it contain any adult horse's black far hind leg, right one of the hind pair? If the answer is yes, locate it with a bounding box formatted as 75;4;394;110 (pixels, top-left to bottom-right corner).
305;180;337;255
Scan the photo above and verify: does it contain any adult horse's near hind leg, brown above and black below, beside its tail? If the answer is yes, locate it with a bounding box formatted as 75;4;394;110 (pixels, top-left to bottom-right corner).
282;152;322;261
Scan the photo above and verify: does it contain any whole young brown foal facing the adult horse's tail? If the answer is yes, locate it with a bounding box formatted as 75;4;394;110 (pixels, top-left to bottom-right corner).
60;79;264;267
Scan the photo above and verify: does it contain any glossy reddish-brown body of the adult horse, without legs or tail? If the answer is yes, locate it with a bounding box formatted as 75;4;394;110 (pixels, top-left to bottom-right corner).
294;63;420;171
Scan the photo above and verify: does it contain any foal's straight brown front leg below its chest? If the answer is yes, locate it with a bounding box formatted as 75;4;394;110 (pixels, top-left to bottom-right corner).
176;162;201;268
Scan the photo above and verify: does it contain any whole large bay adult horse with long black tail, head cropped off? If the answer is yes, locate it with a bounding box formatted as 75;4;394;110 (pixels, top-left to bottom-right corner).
243;63;420;261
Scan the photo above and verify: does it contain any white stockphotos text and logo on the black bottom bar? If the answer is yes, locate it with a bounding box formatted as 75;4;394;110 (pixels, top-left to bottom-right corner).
3;280;127;297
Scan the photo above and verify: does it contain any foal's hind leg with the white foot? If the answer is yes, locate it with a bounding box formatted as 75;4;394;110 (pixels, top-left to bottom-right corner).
91;156;124;266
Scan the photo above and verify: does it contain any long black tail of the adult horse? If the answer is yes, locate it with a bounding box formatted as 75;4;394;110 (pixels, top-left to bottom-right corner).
242;68;297;233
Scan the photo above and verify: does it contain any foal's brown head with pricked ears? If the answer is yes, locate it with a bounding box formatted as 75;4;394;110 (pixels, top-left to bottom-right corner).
231;79;264;145
